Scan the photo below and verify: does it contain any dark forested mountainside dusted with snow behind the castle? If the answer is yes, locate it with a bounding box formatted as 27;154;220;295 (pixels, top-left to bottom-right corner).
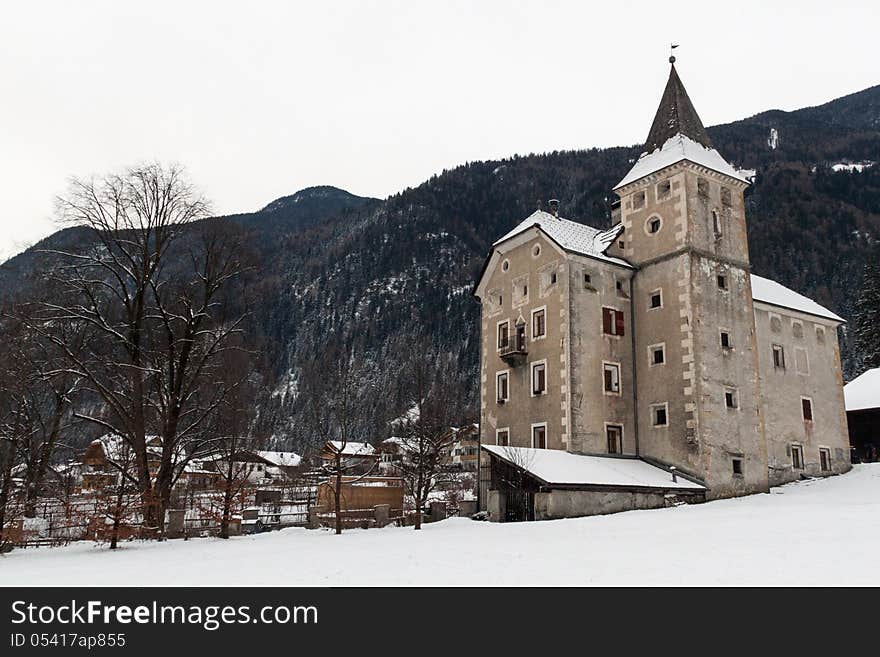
0;80;880;449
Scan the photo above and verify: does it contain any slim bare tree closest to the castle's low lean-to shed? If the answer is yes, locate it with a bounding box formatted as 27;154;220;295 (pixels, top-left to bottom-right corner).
397;339;455;530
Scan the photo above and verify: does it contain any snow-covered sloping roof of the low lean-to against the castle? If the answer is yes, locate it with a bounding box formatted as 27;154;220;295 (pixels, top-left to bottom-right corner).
482;445;705;490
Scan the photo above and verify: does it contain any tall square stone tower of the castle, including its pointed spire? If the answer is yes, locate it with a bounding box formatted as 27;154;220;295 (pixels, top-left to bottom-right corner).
609;58;768;497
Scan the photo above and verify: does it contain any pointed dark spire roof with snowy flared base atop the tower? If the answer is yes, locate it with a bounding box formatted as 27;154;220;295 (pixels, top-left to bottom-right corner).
614;64;749;189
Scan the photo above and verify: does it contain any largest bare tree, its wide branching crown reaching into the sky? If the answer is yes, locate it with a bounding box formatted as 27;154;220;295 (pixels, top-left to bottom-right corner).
34;164;243;532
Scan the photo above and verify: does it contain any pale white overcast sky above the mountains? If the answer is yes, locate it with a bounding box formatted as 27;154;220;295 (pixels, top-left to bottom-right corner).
0;0;880;260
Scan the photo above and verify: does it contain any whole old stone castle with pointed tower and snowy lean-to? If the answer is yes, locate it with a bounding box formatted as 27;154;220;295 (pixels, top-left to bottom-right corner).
474;58;850;520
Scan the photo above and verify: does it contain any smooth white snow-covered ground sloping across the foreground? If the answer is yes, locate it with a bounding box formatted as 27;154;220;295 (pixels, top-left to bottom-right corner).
6;464;880;586
